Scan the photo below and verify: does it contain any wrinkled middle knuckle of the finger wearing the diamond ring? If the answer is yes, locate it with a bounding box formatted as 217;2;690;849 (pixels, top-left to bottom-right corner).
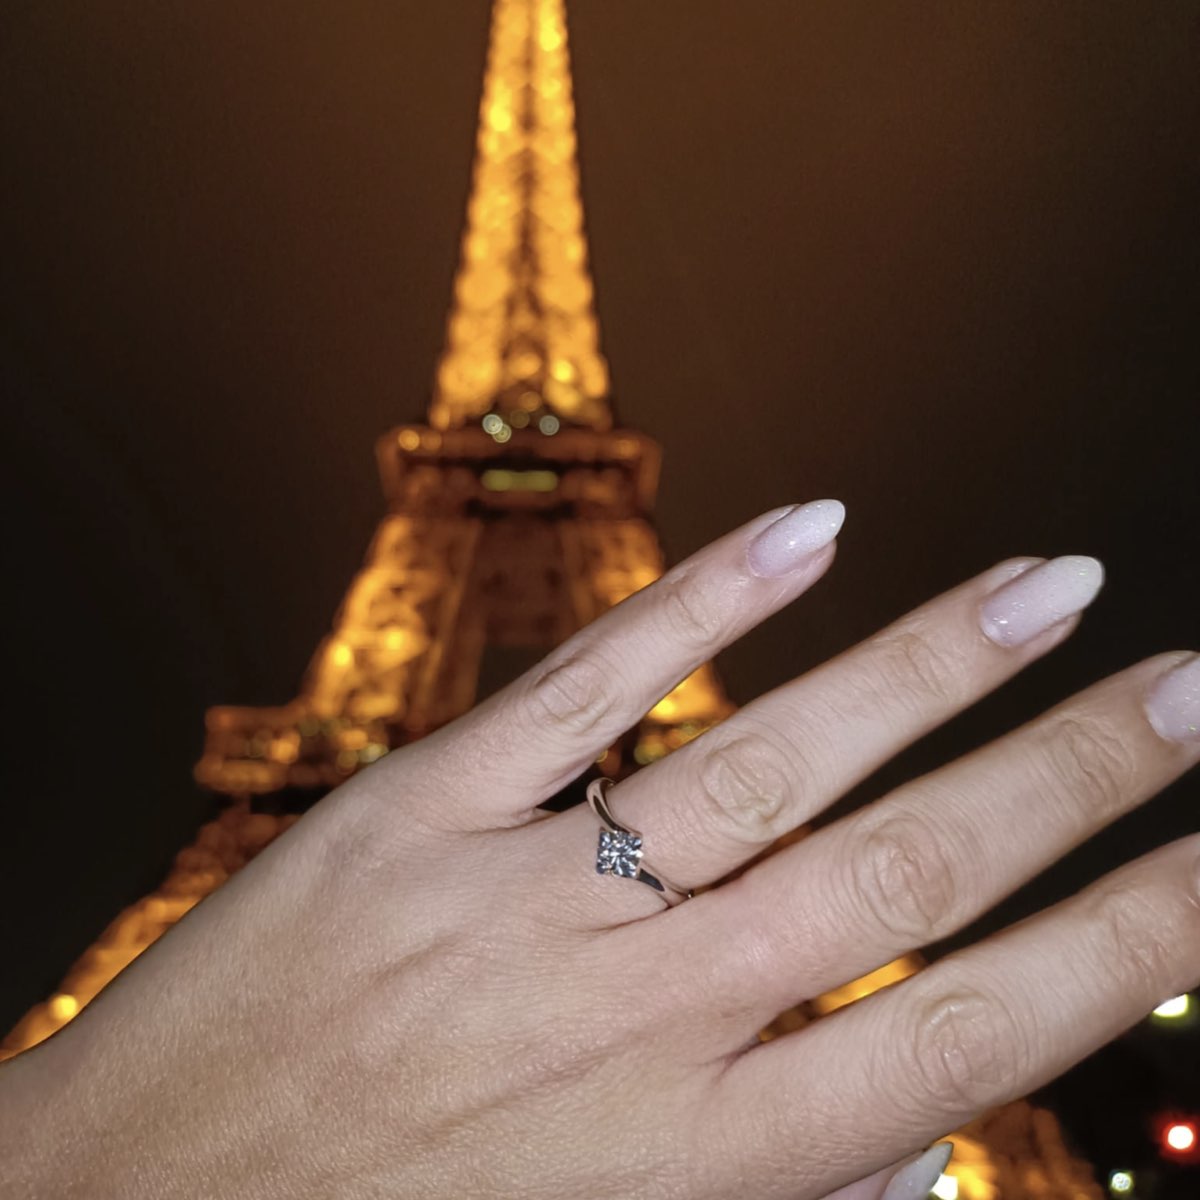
696;733;793;845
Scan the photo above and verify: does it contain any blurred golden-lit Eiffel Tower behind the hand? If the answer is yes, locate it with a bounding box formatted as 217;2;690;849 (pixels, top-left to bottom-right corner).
0;0;1102;1200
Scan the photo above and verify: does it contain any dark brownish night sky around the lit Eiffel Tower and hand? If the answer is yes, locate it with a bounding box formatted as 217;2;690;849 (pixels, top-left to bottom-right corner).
0;0;1200;1194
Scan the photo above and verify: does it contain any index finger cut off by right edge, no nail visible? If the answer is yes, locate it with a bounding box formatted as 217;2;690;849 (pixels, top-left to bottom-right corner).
696;835;1200;1200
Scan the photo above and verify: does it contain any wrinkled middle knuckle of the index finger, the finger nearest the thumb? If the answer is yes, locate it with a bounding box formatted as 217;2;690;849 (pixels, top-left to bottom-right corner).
900;985;1030;1117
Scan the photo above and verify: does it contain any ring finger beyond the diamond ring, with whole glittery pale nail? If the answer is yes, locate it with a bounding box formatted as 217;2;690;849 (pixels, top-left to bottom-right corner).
590;556;1103;888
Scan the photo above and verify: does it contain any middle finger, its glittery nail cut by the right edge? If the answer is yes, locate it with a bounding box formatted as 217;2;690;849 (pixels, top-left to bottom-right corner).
673;653;1200;1048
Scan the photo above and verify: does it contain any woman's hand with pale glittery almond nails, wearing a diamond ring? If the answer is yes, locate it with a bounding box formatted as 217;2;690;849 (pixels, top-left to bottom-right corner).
0;502;1200;1200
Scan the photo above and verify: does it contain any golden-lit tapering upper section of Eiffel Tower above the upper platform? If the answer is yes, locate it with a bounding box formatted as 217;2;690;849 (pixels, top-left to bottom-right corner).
430;0;613;440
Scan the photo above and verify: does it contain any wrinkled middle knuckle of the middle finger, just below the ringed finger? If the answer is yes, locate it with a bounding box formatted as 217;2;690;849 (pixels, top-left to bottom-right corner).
850;812;961;949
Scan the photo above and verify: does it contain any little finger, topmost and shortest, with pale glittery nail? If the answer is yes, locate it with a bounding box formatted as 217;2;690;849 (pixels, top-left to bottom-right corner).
391;500;845;828
